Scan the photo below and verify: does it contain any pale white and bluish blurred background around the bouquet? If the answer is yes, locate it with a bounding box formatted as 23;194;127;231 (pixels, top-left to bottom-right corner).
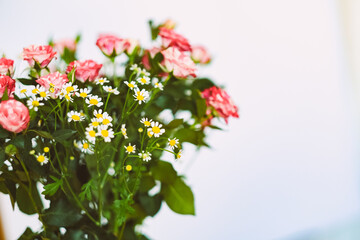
0;0;360;240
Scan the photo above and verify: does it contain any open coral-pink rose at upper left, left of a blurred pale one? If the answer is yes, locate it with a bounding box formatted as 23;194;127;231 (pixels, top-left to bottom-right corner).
22;45;56;68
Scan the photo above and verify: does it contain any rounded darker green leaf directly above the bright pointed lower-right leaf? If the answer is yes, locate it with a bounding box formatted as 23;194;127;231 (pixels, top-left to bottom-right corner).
151;160;177;184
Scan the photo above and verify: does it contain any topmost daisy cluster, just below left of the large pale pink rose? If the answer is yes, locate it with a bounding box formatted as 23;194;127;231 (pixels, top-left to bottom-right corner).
124;64;164;104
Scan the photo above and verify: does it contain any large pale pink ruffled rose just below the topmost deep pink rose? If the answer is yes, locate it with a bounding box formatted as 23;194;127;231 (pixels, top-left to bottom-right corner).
161;47;196;78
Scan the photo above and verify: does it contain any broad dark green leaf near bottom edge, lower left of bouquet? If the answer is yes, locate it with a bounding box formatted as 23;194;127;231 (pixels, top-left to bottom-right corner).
43;198;82;227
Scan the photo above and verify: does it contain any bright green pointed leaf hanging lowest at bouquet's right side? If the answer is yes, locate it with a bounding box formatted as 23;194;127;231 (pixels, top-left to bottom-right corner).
161;177;195;215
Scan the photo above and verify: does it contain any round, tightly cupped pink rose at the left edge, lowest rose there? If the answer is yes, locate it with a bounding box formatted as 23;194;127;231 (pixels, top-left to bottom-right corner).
0;99;30;133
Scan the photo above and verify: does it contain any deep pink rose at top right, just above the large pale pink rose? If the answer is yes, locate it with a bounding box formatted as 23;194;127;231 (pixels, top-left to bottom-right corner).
159;27;191;51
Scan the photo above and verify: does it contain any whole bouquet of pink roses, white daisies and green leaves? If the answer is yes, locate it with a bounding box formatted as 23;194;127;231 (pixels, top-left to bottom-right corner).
0;21;239;240
